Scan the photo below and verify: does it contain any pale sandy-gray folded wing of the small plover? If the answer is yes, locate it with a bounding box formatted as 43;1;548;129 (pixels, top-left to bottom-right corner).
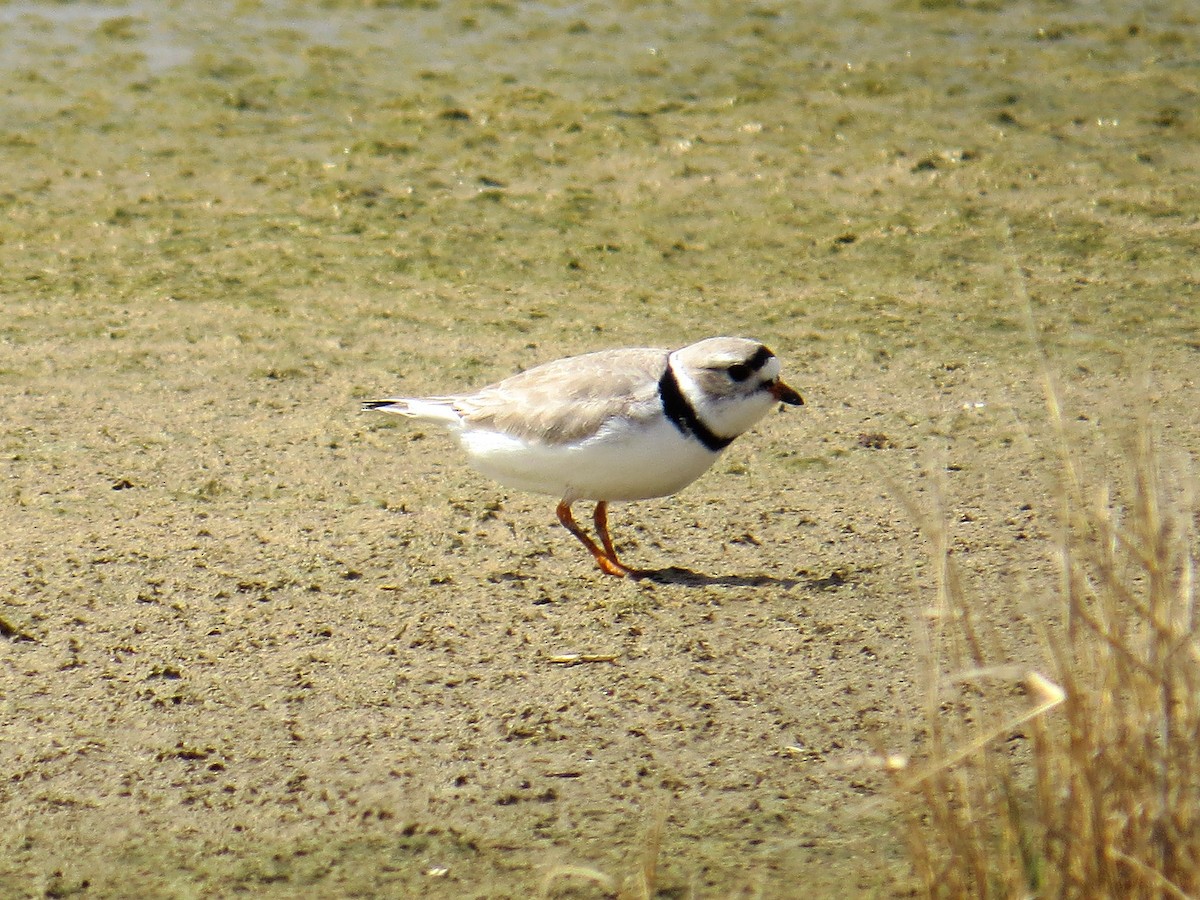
455;349;667;444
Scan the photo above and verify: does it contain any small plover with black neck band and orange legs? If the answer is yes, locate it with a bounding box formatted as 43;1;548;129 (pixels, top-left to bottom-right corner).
362;337;804;577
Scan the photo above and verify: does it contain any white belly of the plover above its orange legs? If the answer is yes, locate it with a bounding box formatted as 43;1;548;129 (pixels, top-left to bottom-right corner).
458;419;720;500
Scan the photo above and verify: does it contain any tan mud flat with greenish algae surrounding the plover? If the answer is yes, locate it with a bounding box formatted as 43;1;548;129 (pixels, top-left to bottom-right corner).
0;4;1200;898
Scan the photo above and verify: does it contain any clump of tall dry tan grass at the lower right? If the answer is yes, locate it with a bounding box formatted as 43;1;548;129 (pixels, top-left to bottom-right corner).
892;355;1200;898
